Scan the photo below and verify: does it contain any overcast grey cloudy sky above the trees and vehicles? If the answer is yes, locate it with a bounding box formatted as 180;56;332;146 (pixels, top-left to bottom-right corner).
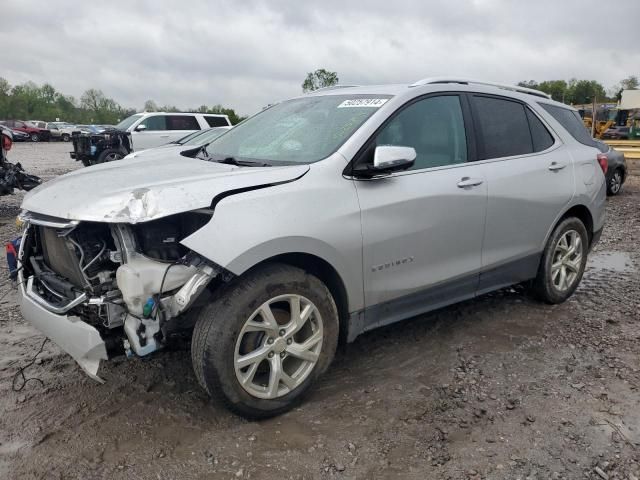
0;0;640;114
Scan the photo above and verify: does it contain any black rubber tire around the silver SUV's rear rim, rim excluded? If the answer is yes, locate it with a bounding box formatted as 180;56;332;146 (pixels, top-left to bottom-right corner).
533;217;589;304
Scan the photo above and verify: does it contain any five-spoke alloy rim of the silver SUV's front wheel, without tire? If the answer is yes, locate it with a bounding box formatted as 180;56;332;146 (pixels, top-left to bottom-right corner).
234;294;323;399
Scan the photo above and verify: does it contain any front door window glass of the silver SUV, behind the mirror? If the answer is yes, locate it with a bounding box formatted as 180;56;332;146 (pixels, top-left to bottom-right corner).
376;95;467;170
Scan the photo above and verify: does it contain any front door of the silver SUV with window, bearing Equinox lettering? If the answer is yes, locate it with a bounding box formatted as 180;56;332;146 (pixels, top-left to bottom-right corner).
355;94;487;329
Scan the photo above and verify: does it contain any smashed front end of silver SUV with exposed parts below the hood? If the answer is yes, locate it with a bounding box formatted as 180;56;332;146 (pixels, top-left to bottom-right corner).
18;210;231;380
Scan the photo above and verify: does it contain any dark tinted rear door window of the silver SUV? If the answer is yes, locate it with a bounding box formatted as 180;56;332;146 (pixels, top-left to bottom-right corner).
473;96;533;160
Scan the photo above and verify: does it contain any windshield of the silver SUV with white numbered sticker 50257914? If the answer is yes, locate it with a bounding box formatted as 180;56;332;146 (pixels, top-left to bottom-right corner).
207;95;390;163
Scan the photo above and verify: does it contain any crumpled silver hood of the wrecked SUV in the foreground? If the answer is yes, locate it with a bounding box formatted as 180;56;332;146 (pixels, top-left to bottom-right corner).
22;154;309;223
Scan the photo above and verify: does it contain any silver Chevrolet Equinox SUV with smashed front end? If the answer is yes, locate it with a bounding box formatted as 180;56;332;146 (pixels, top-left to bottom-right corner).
19;78;606;418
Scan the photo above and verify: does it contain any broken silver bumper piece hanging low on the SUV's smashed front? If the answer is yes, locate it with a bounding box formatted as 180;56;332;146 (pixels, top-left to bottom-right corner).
19;272;108;382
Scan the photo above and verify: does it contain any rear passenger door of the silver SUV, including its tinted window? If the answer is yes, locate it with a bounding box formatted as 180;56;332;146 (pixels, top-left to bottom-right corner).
471;94;575;293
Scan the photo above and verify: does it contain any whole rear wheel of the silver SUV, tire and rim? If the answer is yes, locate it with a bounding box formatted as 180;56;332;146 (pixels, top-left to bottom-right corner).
533;217;589;304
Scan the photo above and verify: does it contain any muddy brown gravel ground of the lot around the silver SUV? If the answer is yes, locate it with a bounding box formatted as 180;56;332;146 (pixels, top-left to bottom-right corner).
0;144;640;480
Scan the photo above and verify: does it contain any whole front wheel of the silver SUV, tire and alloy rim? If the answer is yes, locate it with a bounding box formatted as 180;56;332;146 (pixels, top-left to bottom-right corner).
191;264;338;419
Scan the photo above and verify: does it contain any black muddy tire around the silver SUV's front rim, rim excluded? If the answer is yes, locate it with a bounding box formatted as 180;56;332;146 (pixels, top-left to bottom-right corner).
191;264;339;419
